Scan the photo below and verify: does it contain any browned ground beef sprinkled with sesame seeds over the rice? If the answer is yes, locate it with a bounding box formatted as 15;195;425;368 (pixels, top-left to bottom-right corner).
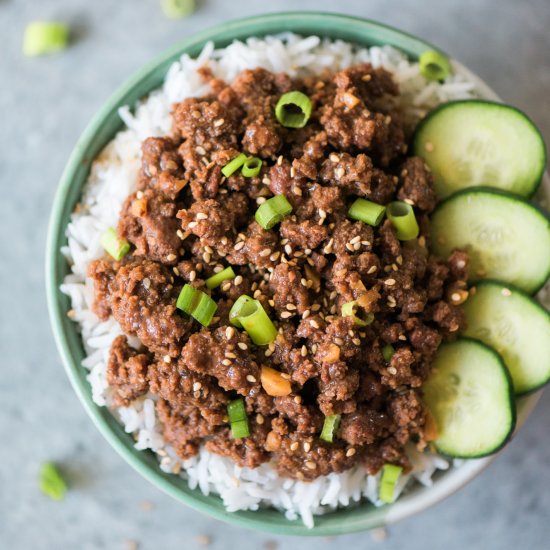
89;65;468;480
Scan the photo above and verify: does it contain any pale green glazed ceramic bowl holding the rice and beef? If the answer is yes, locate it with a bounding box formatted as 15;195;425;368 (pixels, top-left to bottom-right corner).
46;12;536;535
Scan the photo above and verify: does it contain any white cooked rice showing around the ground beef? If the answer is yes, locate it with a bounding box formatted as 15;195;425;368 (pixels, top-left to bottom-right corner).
61;34;484;527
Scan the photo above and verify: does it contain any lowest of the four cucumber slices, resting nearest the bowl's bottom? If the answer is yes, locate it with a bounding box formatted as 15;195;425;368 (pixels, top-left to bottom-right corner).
423;338;516;458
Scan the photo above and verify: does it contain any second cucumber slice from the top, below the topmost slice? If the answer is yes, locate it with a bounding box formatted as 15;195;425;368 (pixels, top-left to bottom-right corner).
431;188;550;294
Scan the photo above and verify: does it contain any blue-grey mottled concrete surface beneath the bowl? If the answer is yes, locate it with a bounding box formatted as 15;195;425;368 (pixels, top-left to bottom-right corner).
0;0;550;550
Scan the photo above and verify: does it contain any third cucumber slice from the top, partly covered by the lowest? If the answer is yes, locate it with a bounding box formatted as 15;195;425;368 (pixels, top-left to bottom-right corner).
463;281;550;395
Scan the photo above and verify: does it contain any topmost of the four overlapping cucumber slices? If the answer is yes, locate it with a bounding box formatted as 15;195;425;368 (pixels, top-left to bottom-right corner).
413;100;546;197
